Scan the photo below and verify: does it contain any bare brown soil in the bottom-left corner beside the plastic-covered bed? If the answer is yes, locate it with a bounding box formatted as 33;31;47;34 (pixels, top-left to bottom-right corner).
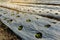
0;22;21;40
